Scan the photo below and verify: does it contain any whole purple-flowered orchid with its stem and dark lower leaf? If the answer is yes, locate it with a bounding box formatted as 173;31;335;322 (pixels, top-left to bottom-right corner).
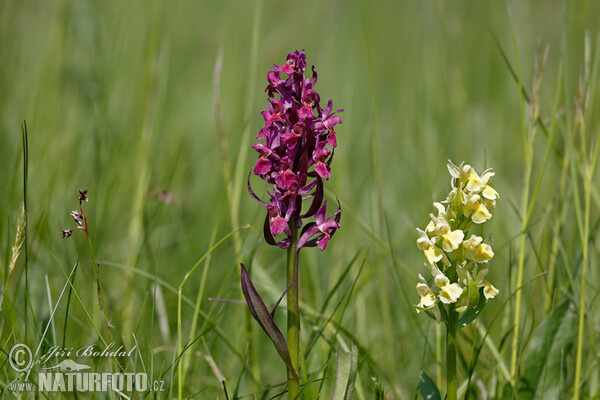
241;50;343;399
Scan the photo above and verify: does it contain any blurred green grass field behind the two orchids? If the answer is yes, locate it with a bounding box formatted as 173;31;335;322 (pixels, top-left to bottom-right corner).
0;0;600;399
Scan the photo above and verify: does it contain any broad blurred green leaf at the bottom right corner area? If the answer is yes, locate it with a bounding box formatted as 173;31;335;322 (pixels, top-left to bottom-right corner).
519;301;577;400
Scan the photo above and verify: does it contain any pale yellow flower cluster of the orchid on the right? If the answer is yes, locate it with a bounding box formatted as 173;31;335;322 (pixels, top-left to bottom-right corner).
415;161;499;320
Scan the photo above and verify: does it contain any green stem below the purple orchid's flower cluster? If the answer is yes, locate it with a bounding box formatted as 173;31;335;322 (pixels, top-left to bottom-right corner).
287;218;300;399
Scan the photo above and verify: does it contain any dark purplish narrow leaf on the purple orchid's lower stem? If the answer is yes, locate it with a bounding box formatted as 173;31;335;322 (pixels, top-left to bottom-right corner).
240;264;297;373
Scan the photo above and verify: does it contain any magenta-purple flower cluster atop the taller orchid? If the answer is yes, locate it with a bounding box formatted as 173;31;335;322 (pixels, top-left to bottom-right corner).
248;51;343;250
